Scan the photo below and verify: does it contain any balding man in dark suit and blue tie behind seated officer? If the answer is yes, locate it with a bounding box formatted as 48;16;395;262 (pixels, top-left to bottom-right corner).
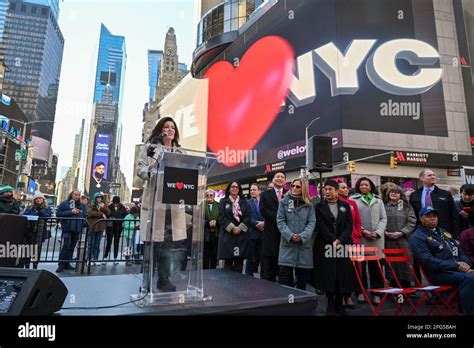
410;169;457;233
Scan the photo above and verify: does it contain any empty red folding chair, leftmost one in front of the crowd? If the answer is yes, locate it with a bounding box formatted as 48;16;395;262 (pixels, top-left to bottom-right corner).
349;246;416;316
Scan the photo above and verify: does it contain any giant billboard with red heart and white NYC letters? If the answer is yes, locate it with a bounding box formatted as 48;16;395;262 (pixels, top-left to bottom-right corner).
198;0;448;179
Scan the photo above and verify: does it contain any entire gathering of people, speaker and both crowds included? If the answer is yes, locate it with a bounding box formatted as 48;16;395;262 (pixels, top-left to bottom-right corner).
0;117;474;315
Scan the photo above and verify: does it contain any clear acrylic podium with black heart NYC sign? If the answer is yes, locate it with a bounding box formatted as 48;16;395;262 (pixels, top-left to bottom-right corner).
130;146;217;307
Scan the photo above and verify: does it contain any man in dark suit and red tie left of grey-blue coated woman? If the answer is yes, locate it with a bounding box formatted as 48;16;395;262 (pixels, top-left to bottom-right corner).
260;172;286;282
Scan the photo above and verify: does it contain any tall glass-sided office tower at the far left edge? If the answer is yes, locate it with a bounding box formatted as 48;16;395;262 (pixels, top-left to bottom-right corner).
0;0;64;142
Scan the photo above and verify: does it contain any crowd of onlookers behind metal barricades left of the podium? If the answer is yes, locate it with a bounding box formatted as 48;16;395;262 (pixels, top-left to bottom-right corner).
0;185;142;273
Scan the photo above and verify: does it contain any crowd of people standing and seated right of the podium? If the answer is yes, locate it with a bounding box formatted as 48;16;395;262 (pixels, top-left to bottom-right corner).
200;169;474;314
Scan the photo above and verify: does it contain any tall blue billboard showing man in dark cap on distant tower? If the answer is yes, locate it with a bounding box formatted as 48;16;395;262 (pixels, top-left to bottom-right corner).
89;133;111;196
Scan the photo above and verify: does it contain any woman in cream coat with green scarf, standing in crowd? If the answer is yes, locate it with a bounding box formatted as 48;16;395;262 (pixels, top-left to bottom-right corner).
351;177;387;304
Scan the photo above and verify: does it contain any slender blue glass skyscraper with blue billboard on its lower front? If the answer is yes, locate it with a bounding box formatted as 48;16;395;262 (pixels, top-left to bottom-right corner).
86;24;127;195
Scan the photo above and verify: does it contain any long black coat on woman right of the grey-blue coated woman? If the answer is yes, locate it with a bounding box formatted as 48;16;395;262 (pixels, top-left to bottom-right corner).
313;200;359;293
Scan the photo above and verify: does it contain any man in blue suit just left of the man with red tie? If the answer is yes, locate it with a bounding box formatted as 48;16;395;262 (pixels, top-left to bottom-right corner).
245;184;264;278
